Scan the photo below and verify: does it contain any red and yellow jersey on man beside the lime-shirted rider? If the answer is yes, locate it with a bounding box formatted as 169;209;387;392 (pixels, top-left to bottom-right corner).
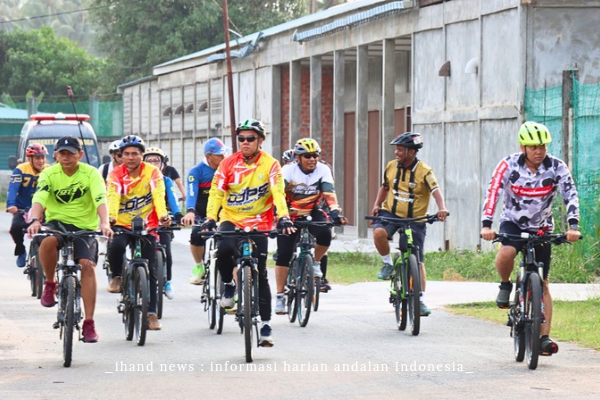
107;162;168;228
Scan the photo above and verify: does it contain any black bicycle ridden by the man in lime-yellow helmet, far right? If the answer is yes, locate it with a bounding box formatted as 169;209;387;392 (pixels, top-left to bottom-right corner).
493;232;583;369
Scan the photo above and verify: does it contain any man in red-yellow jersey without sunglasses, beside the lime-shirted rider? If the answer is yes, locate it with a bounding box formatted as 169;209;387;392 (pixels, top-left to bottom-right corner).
107;135;171;330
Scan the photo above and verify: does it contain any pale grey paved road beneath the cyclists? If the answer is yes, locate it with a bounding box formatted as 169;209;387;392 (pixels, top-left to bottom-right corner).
0;215;600;399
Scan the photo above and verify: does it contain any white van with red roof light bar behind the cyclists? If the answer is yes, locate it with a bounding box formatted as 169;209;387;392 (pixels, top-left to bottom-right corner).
8;113;100;169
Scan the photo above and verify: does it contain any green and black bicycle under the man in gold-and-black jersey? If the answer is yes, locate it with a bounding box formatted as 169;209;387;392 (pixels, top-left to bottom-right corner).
365;215;438;336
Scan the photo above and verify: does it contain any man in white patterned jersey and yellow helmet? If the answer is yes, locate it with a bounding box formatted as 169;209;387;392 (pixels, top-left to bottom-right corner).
275;138;346;314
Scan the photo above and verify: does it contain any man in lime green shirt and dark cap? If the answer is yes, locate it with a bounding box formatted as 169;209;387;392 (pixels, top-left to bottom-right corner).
27;136;112;343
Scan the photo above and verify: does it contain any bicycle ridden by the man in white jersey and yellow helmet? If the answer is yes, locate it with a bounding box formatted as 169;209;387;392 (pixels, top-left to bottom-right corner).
286;216;335;328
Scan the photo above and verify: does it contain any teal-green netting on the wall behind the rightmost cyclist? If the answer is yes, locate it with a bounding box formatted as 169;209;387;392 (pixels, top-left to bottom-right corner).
525;74;600;241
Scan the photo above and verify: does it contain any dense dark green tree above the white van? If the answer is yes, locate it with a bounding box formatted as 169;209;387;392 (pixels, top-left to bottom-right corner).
0;27;105;101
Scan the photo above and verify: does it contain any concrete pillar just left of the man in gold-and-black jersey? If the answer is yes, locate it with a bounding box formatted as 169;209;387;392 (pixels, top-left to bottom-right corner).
354;45;369;238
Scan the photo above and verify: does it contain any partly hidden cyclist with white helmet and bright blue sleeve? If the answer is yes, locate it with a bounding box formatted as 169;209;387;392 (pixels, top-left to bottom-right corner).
144;147;183;300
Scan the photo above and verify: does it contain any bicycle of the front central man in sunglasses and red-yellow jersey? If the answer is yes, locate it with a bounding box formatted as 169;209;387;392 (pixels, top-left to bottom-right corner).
202;228;278;362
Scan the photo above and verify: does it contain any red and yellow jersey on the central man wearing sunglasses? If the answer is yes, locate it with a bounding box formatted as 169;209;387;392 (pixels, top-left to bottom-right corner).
206;151;288;230
